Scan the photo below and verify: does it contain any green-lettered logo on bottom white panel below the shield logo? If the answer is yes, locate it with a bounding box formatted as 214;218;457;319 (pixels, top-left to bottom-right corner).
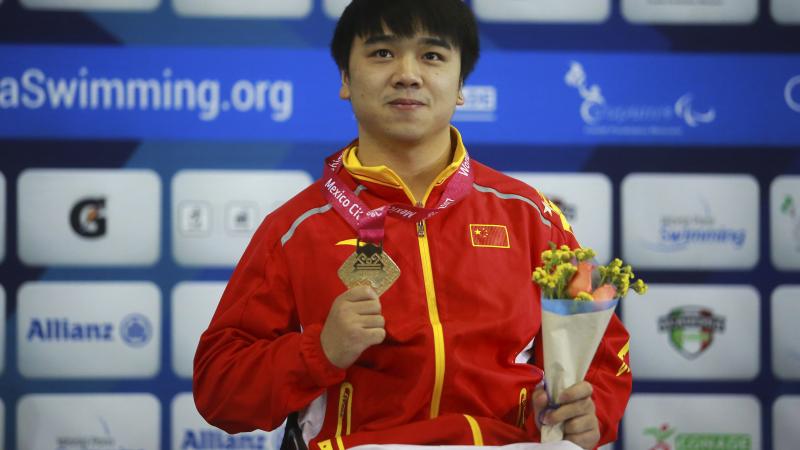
643;423;753;450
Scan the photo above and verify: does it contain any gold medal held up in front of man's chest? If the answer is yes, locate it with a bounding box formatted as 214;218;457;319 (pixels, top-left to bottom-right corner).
339;242;400;296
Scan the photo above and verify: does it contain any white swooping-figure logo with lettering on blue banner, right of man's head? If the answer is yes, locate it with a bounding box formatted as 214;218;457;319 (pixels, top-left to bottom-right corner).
564;61;717;128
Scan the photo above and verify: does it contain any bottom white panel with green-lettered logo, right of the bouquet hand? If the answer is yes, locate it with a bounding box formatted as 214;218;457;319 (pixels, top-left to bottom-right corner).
623;396;762;450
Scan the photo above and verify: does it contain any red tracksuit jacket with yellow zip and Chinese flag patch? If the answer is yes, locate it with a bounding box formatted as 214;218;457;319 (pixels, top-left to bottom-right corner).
194;129;631;450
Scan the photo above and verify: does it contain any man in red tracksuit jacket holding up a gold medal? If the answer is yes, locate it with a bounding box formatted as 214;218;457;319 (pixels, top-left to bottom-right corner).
194;0;631;450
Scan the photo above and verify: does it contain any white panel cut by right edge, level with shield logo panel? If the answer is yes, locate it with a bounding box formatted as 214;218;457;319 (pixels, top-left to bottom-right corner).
771;286;800;380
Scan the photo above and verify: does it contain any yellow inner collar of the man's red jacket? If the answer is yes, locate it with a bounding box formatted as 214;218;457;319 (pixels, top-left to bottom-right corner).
342;125;467;204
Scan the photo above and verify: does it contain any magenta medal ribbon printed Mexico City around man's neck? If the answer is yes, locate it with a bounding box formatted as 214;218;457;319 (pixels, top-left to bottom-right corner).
322;146;475;245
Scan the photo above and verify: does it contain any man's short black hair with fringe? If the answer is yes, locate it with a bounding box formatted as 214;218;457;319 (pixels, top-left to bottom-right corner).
331;0;480;81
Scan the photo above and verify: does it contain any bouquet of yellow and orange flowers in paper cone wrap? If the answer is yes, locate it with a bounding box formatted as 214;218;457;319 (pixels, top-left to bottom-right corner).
533;242;647;442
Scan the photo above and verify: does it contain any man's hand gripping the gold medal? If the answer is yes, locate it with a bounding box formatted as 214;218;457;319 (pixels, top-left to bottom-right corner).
320;286;386;369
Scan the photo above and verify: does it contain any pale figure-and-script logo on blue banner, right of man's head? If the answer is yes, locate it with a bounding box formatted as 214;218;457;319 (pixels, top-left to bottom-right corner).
564;61;717;136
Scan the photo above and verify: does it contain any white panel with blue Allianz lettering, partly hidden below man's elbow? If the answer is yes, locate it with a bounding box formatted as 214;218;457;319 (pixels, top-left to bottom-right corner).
171;393;283;450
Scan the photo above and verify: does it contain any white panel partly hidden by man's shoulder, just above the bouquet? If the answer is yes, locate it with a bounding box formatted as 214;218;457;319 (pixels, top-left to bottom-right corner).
507;172;614;264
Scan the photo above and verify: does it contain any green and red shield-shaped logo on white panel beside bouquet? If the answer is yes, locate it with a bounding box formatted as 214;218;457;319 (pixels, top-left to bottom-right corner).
658;306;725;360
